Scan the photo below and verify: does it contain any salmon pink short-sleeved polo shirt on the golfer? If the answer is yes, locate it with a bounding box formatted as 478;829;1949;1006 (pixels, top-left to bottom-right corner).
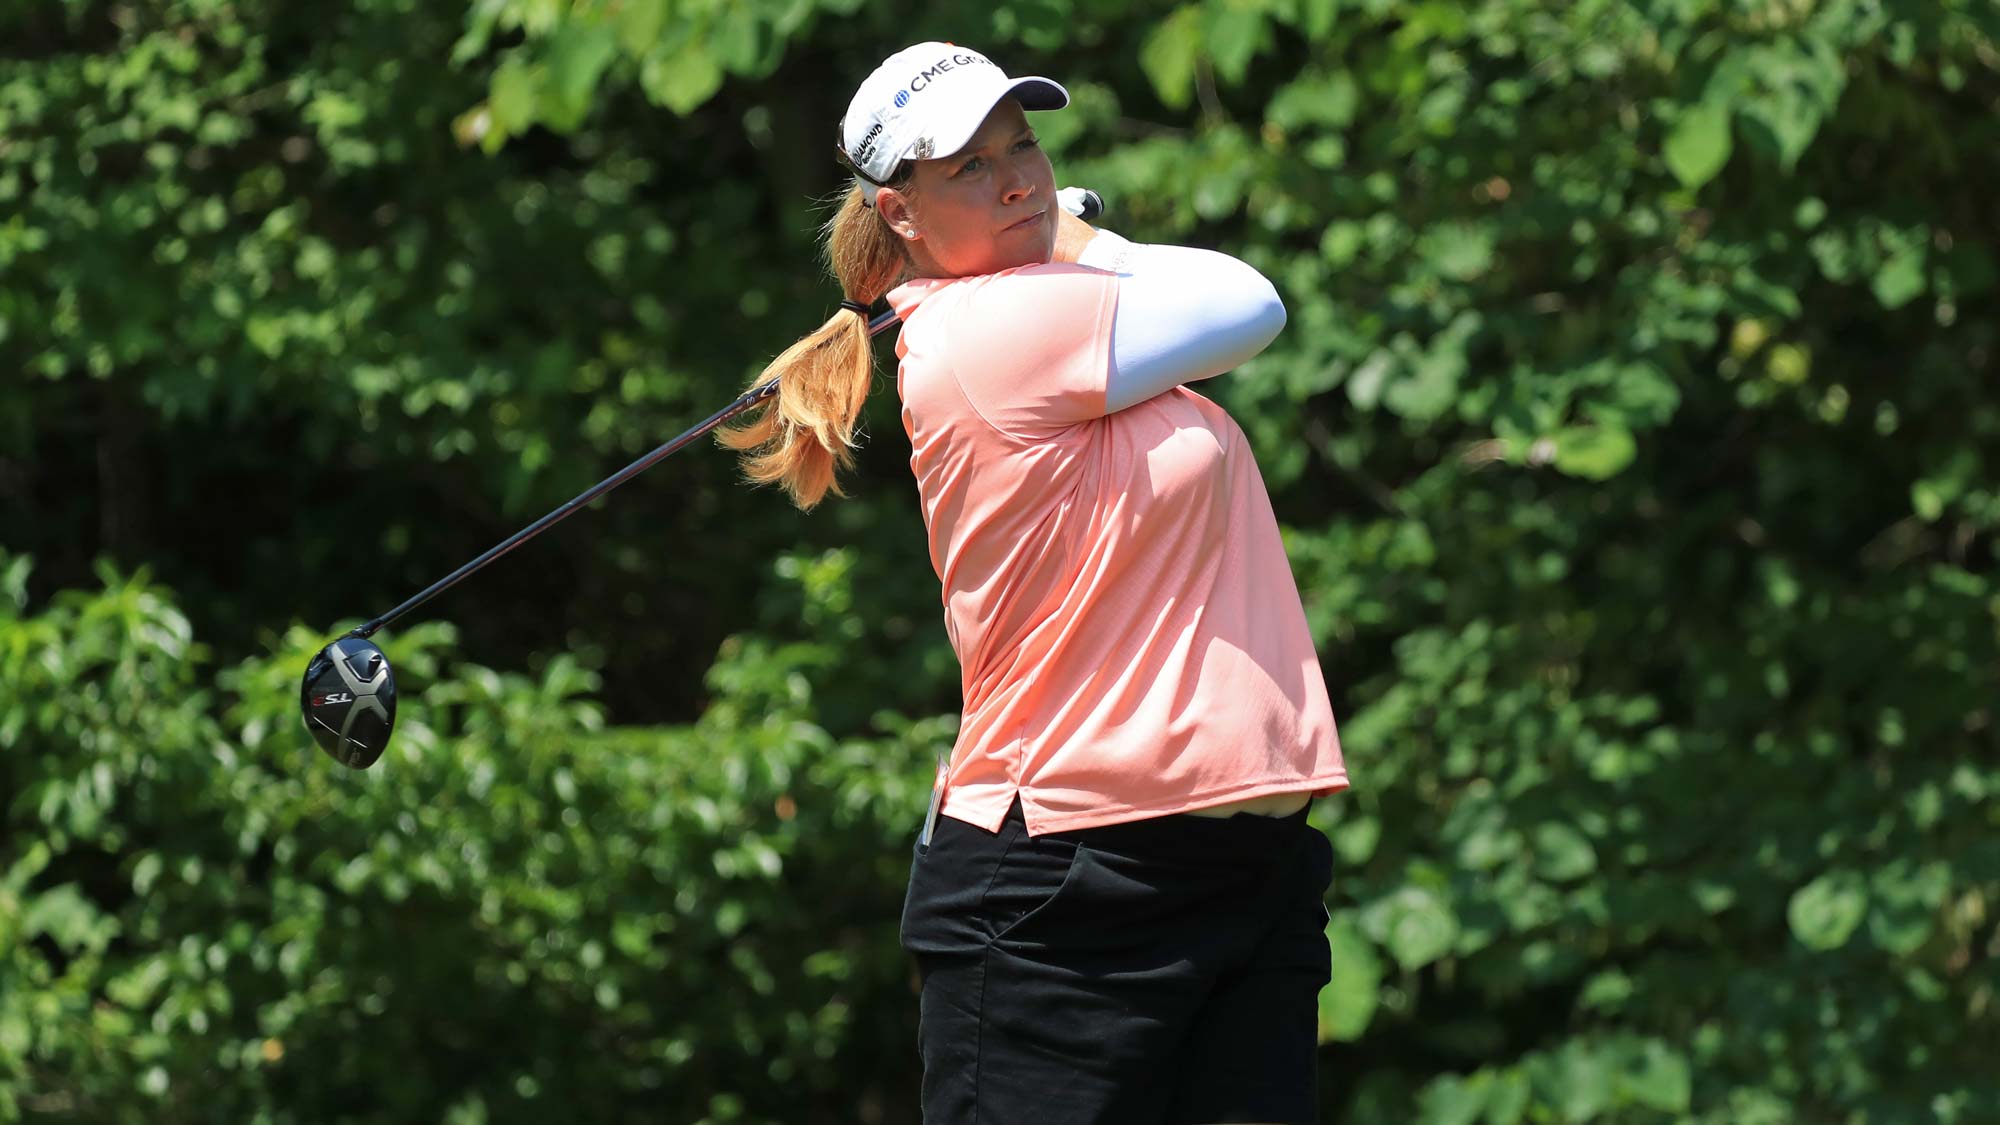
888;264;1348;835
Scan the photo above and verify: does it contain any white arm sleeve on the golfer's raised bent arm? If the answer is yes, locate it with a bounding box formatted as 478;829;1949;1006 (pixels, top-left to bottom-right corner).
1076;230;1284;412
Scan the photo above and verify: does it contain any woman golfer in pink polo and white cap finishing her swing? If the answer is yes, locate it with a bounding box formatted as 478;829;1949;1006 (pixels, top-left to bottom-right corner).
726;42;1348;1125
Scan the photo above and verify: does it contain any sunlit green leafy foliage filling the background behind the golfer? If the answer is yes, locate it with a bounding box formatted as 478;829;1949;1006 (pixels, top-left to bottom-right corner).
0;0;2000;1125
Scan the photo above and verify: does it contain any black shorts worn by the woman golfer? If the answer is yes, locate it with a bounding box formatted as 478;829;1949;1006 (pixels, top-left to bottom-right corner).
902;801;1334;1125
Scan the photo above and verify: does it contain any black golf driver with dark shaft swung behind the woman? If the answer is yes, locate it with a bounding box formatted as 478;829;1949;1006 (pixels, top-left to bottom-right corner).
298;188;1104;769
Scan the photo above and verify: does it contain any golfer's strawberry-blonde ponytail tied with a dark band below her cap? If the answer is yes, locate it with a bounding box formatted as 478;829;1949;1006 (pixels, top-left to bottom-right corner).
718;182;910;510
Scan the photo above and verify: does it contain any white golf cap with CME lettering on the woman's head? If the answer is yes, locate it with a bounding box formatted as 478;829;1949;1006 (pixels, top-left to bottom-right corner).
840;42;1070;188
